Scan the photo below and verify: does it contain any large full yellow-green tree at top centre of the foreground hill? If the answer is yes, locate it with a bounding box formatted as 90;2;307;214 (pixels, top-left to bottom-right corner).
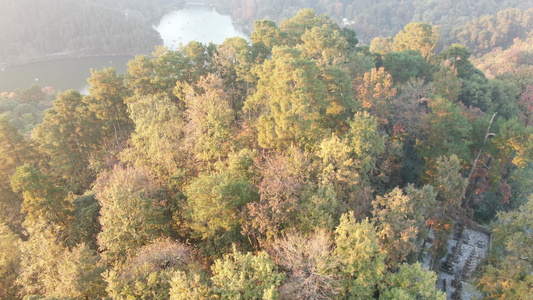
244;47;326;150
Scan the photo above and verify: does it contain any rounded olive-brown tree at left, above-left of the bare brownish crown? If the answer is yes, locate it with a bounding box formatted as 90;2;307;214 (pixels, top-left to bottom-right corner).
94;166;170;264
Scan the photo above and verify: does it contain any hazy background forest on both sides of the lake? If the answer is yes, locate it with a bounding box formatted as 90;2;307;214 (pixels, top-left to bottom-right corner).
0;0;533;65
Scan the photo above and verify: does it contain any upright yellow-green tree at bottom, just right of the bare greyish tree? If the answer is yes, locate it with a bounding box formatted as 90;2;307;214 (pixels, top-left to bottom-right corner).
334;212;386;299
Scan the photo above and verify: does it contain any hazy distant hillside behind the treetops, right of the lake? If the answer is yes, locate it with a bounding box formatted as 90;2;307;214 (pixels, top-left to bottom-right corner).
214;0;533;44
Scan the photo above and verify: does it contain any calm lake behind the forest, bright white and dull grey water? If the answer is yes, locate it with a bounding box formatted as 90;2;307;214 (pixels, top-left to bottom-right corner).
0;6;246;93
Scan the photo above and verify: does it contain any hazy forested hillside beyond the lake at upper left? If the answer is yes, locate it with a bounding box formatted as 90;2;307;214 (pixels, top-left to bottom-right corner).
0;0;183;65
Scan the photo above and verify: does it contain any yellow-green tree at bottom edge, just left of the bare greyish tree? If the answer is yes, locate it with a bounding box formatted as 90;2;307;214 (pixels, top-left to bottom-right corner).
211;248;285;299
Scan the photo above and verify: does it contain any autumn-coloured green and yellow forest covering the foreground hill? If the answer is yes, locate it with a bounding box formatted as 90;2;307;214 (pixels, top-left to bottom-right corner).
0;1;533;300
